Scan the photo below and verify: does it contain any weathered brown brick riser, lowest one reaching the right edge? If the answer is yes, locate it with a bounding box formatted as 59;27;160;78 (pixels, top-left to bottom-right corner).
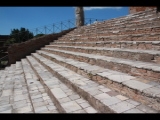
37;51;160;110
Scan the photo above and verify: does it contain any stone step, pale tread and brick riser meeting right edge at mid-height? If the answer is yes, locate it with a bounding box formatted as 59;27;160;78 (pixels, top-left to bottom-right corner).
42;48;160;82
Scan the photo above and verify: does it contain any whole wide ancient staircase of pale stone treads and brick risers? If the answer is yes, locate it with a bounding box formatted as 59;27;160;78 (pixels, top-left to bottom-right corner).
0;9;160;113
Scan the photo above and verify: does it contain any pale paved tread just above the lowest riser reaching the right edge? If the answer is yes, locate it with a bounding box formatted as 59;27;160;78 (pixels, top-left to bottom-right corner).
38;51;160;98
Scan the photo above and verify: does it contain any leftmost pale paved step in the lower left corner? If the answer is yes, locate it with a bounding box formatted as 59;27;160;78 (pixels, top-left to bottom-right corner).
0;64;15;113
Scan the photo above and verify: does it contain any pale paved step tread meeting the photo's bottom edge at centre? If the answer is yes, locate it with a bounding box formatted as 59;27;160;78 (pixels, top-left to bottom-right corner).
27;56;97;113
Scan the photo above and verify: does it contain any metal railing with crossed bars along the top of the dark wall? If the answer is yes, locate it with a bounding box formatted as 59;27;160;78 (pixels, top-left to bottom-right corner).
7;18;104;42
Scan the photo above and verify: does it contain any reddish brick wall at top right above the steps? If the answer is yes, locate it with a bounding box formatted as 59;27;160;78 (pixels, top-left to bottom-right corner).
129;6;156;14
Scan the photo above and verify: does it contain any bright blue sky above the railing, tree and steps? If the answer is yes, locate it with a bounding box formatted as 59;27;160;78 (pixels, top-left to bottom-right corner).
0;6;129;35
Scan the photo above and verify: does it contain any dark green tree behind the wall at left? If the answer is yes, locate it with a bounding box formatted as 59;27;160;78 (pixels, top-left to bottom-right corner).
10;27;33;43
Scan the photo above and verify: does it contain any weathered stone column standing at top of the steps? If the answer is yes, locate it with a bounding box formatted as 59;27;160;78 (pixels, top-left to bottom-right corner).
75;7;84;27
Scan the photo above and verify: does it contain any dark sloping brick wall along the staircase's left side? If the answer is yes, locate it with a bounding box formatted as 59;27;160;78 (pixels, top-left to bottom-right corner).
7;28;74;65
